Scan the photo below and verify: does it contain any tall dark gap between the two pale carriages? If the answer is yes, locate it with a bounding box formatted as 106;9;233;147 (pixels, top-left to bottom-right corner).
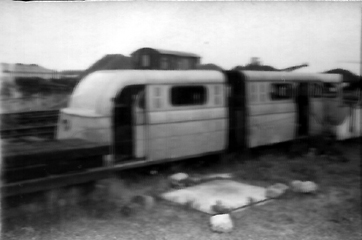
226;71;247;151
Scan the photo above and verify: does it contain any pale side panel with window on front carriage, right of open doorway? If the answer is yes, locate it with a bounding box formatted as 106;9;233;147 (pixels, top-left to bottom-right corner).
147;83;227;160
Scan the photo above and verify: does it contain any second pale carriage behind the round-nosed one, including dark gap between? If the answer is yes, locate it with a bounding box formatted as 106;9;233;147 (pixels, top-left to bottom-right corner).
226;71;346;149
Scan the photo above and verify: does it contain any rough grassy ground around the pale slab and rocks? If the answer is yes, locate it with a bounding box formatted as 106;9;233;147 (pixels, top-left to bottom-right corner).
1;141;362;240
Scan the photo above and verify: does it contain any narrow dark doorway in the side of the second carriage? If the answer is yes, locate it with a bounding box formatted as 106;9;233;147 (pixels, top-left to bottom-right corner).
296;83;309;137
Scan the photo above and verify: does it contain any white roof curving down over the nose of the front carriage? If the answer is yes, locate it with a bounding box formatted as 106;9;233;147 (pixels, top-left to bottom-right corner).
62;70;224;117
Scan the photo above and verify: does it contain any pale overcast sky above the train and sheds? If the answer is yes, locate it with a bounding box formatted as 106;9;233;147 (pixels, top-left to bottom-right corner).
0;1;362;73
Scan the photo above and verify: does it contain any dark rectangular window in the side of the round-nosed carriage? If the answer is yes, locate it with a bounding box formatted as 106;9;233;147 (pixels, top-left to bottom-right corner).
171;86;206;106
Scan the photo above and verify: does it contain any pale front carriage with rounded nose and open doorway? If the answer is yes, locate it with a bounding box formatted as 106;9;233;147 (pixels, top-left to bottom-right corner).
58;70;228;161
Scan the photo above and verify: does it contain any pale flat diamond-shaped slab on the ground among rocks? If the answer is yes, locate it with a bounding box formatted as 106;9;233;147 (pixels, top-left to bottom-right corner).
161;179;267;214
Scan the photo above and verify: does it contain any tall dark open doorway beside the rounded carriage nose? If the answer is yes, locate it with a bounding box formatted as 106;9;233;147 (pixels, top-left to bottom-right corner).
112;85;144;161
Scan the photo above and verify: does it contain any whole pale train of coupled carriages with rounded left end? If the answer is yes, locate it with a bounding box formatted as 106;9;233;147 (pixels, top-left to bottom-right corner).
58;70;361;166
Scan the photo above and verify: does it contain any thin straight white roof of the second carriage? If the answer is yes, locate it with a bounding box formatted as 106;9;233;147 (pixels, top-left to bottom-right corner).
240;71;342;82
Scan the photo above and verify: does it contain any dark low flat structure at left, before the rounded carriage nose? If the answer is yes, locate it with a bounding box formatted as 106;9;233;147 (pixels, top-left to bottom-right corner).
0;139;109;197
